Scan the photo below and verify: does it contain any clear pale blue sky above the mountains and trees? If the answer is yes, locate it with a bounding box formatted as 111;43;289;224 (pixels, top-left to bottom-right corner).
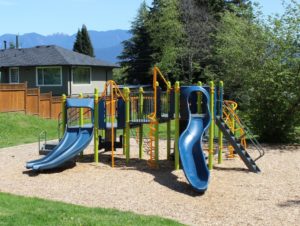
0;0;288;35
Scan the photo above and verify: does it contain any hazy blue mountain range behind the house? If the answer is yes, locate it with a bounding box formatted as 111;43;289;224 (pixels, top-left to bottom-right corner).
0;30;131;63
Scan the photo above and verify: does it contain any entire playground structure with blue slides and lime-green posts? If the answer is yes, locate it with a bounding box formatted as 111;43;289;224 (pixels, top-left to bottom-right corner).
26;67;264;192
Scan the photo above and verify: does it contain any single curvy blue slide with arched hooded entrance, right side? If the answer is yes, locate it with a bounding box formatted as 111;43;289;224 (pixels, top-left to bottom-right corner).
179;86;211;192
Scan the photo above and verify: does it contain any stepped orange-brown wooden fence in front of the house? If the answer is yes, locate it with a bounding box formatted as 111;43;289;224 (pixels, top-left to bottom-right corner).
0;83;61;119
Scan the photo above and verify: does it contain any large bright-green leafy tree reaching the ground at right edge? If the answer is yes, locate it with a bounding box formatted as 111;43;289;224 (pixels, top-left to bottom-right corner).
215;1;300;142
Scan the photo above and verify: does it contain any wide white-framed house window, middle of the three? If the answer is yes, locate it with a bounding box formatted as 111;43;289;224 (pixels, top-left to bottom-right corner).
36;67;62;86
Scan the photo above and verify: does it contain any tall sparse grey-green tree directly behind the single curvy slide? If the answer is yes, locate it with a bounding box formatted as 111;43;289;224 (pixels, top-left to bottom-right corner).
180;0;216;82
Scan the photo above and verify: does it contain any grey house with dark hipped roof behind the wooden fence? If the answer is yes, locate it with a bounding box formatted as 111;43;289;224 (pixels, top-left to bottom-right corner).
0;45;117;95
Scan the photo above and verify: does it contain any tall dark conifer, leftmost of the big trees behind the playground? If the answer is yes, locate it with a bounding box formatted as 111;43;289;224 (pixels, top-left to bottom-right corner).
118;2;153;84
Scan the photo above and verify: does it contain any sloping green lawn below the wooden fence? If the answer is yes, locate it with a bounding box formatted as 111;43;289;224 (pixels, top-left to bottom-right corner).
0;113;57;148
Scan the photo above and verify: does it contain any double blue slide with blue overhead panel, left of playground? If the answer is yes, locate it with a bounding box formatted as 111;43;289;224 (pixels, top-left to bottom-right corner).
26;98;94;171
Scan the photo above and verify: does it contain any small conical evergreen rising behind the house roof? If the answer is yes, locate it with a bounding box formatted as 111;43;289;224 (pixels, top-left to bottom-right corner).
73;25;95;57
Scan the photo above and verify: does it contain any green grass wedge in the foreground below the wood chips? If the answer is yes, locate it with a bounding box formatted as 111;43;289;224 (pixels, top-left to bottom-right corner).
0;193;181;226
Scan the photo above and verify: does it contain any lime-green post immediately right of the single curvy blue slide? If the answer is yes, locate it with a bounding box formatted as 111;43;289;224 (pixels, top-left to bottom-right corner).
208;81;215;170
